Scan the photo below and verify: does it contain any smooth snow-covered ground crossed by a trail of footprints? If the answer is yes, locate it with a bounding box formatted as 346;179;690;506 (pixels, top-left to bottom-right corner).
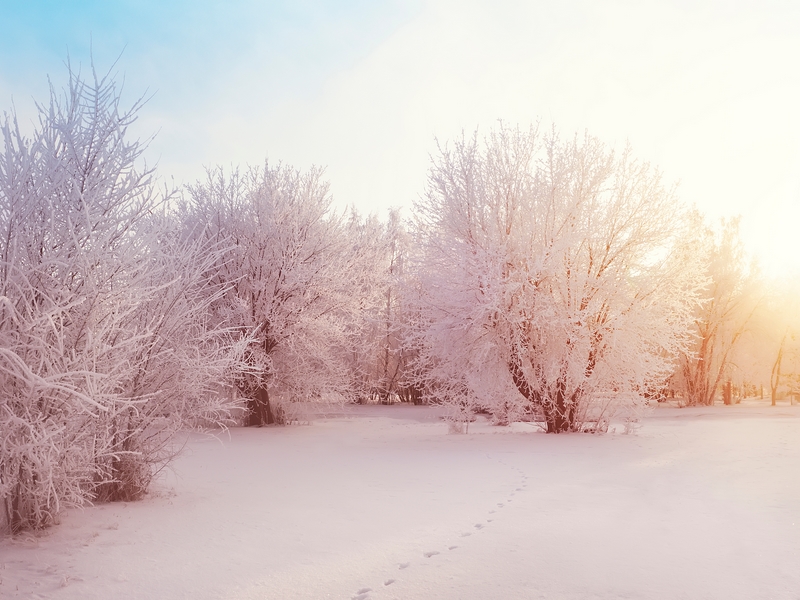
0;398;800;600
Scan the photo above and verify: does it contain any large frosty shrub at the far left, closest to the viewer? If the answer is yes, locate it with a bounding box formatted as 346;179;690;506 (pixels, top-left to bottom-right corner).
0;69;247;531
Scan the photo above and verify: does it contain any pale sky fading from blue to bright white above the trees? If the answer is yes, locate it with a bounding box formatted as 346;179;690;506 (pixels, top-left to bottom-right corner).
0;0;800;276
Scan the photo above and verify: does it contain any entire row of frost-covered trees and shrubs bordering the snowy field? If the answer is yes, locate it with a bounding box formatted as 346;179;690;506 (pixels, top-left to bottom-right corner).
0;72;791;531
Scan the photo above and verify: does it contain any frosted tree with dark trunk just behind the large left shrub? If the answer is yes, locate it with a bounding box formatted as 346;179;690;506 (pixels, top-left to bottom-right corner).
182;164;380;425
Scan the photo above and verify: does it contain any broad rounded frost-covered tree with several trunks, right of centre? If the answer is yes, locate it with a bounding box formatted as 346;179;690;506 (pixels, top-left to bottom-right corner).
416;126;702;432
